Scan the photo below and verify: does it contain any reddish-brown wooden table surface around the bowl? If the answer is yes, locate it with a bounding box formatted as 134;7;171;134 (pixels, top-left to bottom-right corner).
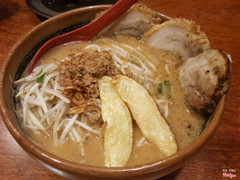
0;0;240;179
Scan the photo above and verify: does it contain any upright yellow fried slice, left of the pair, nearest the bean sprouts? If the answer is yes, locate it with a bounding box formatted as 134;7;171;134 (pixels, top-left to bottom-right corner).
99;76;133;167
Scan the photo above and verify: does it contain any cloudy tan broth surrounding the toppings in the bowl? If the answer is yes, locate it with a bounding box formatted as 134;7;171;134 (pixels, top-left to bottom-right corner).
20;36;205;166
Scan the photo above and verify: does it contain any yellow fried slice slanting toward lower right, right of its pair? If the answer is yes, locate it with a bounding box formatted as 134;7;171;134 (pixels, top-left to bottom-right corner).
111;75;177;156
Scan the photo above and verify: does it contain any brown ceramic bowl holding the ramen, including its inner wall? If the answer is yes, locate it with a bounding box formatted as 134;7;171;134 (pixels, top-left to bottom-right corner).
0;5;225;179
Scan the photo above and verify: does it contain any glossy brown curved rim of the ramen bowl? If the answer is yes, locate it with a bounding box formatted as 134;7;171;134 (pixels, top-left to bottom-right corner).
0;5;226;177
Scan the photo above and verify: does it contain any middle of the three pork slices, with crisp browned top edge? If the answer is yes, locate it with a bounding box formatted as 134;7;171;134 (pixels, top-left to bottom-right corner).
142;18;210;60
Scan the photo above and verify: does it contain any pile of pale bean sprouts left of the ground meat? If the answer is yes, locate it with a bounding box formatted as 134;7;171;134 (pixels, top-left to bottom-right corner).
15;63;100;145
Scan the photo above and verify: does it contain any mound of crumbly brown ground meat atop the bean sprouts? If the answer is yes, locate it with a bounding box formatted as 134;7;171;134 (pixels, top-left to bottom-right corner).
59;51;119;100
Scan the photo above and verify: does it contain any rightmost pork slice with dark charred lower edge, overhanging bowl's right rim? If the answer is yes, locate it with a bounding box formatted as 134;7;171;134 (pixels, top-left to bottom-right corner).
179;49;231;113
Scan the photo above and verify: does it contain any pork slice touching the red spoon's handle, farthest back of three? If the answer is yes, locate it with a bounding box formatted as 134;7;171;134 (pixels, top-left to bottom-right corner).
99;3;162;37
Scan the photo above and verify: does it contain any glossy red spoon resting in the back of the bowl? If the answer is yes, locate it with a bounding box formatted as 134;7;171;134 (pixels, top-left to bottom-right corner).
29;0;138;73
